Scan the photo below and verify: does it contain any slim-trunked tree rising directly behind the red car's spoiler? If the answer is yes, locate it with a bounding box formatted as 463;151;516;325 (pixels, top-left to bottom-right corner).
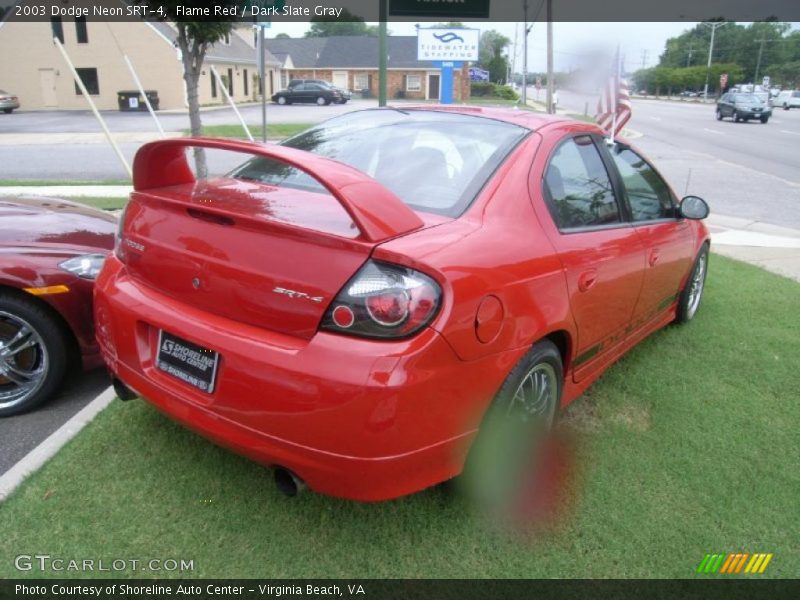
154;0;237;178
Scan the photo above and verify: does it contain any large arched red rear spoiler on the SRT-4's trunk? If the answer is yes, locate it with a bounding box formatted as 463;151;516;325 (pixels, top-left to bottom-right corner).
133;137;423;243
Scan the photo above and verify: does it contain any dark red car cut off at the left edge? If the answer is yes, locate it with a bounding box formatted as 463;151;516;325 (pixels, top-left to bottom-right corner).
0;198;117;417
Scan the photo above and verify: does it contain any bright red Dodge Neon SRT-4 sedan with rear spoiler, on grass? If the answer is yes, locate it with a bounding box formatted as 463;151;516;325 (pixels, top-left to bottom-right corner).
95;107;709;500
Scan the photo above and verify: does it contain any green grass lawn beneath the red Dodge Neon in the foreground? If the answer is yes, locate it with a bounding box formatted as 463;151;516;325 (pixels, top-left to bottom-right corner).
0;255;800;578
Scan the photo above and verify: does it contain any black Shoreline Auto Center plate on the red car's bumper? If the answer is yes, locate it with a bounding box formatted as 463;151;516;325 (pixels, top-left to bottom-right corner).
156;330;219;394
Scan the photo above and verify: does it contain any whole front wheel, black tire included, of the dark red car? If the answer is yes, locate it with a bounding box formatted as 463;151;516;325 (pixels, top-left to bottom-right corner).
0;293;67;417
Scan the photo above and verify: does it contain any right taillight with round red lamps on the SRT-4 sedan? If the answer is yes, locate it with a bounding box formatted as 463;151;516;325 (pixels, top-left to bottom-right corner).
322;260;442;339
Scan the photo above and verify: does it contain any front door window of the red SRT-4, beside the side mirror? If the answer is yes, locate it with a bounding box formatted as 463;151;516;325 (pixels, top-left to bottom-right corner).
611;144;675;221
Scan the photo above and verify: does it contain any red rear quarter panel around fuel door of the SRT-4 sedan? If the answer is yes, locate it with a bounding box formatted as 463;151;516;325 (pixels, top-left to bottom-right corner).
375;134;574;366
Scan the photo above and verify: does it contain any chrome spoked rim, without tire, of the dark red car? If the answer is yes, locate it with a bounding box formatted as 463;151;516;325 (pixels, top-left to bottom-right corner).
0;311;50;410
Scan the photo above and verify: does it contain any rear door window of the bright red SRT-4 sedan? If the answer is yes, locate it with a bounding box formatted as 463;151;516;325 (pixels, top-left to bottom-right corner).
544;136;621;229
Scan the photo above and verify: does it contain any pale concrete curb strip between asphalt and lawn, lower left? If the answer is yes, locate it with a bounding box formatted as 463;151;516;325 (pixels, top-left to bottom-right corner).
0;387;117;503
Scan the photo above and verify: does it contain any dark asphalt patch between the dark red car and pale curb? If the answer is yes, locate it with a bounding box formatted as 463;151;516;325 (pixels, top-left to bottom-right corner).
0;369;110;475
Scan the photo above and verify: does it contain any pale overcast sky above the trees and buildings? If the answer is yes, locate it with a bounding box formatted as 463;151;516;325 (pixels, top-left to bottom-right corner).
266;22;694;72
